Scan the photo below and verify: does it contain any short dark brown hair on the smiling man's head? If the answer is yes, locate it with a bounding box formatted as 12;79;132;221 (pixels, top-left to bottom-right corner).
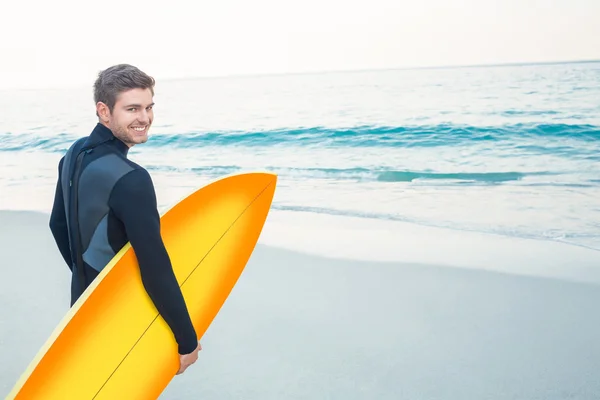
94;64;155;115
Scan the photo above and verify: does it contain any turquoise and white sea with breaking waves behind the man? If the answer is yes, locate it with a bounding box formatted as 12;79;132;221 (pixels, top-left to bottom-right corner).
0;62;600;250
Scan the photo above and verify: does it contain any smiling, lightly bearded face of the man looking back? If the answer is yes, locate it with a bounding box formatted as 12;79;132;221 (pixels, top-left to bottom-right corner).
98;89;154;147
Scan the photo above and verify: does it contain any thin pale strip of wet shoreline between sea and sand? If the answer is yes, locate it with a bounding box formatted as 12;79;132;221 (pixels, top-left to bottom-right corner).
0;209;600;285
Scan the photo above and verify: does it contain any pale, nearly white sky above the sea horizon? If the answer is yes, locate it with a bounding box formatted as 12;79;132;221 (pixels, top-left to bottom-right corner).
0;0;600;88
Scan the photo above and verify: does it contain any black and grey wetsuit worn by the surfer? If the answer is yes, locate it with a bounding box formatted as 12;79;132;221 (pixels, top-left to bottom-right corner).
50;123;198;354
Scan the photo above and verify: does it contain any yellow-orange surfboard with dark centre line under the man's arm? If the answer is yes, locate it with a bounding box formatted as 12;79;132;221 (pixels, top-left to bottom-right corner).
8;173;277;400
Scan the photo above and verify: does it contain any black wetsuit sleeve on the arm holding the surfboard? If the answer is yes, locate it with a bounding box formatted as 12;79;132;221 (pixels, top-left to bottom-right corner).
109;169;198;354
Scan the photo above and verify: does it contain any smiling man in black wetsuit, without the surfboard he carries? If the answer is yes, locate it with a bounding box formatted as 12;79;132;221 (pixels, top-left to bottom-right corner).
50;64;202;375
